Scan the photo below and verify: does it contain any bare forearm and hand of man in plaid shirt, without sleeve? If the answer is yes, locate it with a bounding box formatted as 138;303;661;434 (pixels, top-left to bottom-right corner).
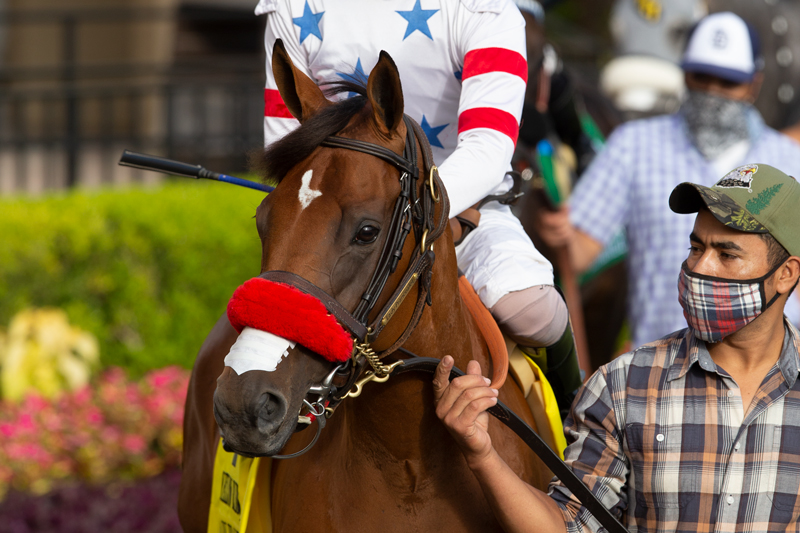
433;356;566;533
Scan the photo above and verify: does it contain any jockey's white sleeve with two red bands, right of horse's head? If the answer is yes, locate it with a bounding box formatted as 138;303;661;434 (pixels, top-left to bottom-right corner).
439;0;528;217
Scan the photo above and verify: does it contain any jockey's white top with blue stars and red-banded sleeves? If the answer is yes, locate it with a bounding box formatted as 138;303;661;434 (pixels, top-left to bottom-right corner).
256;0;528;216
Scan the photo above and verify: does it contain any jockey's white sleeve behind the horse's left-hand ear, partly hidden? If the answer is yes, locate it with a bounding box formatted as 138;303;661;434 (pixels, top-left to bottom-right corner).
256;0;314;146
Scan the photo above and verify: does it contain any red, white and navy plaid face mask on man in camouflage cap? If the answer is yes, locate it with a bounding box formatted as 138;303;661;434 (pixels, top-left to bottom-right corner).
678;261;780;342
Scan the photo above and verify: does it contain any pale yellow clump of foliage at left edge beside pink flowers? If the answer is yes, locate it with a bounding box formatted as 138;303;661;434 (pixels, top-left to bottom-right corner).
0;309;98;401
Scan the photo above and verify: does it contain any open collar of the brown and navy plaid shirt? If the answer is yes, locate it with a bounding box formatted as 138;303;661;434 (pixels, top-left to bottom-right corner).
667;316;800;388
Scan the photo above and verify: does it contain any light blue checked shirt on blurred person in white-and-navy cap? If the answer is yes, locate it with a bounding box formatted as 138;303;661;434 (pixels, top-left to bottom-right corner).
570;112;800;346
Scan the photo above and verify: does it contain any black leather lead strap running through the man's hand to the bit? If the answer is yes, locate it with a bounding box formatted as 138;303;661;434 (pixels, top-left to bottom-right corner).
392;356;629;533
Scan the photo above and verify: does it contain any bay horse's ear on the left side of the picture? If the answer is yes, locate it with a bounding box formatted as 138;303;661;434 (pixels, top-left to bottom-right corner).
272;39;330;122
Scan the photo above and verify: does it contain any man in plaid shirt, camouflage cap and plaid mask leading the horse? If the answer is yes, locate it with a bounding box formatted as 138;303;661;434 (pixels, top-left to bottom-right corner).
434;164;800;532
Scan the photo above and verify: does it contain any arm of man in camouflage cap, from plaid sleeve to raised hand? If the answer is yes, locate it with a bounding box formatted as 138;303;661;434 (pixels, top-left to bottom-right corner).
433;354;631;533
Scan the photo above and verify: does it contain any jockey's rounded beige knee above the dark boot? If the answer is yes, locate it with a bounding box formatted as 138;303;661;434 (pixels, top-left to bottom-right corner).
491;285;569;348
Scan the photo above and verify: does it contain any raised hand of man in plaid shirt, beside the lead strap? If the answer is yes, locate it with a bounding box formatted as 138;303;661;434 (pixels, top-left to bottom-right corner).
433;355;498;466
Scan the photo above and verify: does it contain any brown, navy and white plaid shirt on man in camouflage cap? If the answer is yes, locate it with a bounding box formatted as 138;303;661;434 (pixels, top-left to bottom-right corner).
550;321;800;533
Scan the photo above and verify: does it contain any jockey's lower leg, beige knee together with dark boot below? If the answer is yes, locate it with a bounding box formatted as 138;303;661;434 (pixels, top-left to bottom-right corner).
492;285;583;420
